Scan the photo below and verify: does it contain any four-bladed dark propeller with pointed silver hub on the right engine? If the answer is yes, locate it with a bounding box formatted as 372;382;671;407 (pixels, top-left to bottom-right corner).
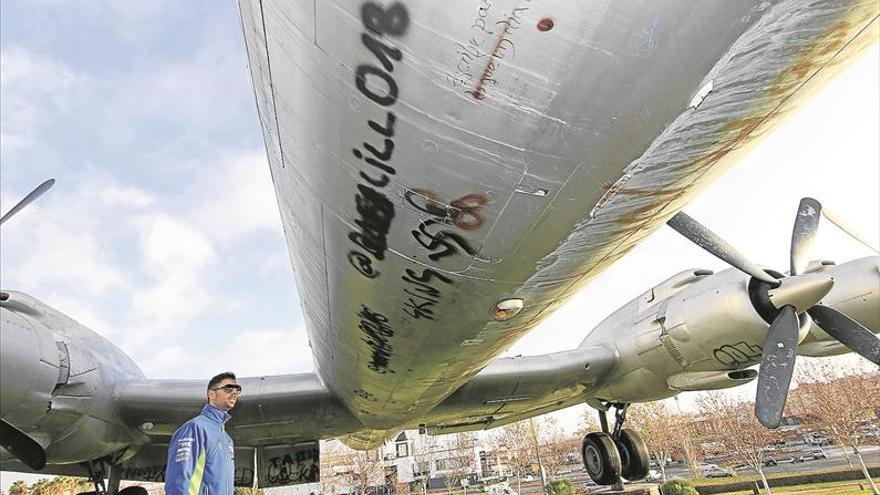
667;198;880;428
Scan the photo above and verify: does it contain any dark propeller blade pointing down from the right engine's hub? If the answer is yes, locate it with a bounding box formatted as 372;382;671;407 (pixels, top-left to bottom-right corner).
755;306;799;428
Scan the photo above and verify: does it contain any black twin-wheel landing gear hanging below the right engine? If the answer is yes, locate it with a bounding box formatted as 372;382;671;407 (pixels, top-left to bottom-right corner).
581;404;650;485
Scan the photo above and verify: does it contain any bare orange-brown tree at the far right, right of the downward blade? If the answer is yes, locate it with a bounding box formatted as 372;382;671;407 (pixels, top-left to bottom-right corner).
791;360;880;495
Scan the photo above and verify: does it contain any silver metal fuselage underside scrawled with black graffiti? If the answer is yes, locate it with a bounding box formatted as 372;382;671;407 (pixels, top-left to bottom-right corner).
241;0;877;436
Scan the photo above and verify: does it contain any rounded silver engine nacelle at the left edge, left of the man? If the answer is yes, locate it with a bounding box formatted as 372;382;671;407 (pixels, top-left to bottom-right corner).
0;292;146;464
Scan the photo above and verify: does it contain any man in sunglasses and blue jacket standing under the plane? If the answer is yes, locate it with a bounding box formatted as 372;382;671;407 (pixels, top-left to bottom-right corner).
165;371;241;495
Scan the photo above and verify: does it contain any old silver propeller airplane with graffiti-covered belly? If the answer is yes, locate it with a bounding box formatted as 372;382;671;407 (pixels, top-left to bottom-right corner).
0;1;880;495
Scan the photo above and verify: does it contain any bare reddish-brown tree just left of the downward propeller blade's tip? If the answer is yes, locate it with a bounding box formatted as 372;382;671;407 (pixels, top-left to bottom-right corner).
697;391;775;495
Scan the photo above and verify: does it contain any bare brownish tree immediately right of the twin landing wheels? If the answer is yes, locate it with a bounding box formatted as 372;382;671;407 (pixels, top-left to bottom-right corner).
627;401;681;481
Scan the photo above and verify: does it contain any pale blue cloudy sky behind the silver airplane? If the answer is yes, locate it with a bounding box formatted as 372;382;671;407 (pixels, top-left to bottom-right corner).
0;0;880;486
